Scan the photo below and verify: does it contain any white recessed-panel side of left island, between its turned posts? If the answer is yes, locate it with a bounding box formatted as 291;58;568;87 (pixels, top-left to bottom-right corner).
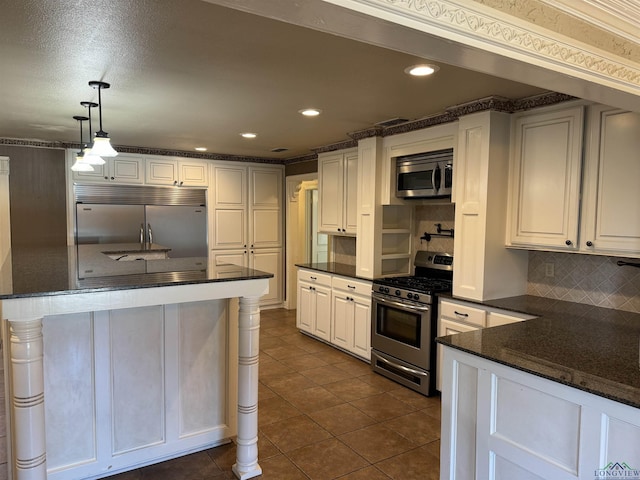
33;300;238;480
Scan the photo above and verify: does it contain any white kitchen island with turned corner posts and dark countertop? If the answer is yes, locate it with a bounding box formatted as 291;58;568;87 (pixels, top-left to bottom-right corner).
0;245;272;480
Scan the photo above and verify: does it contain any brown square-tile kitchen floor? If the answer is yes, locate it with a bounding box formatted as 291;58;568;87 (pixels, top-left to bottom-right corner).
109;309;440;480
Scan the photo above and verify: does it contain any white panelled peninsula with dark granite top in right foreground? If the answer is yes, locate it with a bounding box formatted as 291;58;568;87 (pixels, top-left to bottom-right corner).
437;296;640;480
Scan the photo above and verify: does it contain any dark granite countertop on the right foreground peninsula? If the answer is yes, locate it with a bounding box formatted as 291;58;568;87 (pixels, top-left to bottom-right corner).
437;295;640;408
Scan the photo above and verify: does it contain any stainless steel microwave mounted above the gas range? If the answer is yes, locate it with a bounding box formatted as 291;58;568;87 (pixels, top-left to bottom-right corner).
396;148;453;198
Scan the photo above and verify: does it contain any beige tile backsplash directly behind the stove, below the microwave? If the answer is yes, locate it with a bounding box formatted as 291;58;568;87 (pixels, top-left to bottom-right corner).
411;203;455;255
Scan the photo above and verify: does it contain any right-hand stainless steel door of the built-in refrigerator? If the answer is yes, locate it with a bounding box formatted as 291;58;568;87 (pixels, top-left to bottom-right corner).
145;205;207;258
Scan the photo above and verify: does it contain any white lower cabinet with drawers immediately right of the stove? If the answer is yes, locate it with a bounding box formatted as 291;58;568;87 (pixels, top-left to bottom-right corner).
436;299;535;391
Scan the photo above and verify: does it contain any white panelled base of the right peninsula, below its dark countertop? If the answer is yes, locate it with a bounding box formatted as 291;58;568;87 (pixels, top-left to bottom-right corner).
440;347;640;480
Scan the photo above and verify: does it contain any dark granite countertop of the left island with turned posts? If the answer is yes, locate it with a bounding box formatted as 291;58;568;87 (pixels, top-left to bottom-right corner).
0;248;273;300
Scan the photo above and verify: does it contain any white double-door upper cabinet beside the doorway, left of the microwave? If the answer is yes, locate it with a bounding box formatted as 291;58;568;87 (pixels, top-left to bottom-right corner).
318;149;358;235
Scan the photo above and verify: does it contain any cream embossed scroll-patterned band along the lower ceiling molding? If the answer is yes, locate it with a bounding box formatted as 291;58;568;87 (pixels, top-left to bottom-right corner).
372;0;640;88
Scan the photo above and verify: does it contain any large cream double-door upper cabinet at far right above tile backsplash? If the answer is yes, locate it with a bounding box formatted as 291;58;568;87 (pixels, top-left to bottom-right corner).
507;105;640;256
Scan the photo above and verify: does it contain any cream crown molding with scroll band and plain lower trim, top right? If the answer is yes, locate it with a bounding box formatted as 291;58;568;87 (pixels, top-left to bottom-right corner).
332;0;640;94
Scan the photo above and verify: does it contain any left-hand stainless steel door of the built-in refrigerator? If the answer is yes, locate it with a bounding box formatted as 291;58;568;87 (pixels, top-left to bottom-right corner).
76;203;145;245
